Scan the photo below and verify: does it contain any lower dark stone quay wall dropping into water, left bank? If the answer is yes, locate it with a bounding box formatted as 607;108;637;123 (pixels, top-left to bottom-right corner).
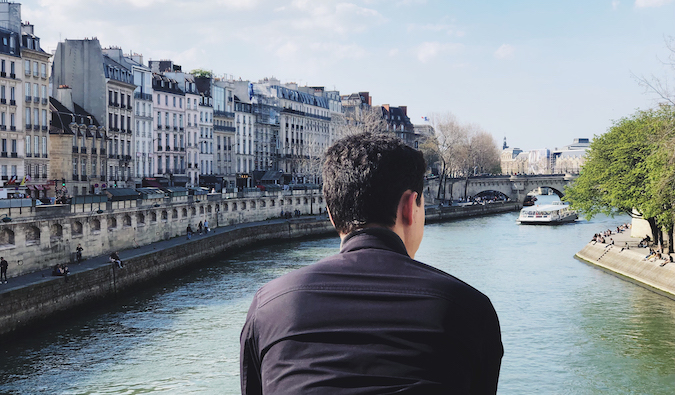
0;218;336;335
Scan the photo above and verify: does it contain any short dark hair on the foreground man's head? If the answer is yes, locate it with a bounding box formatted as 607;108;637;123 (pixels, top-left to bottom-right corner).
323;133;426;235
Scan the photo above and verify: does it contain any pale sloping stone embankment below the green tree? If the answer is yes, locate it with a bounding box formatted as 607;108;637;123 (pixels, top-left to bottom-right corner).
576;242;675;299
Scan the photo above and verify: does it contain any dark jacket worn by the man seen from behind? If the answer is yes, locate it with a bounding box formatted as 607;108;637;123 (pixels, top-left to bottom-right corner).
240;228;504;394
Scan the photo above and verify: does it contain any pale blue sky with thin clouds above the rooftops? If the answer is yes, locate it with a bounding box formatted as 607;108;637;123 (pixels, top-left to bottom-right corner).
20;0;675;150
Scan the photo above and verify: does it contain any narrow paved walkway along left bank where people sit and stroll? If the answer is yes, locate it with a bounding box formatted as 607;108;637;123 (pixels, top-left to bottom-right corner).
0;214;328;295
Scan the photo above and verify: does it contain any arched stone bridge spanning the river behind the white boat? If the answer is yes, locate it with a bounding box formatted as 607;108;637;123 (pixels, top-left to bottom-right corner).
425;174;578;204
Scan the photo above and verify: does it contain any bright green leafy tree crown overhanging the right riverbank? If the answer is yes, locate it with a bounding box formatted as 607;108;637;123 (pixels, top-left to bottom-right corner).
565;107;675;223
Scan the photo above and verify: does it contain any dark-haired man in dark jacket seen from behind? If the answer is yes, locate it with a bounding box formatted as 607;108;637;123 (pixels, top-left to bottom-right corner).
240;134;503;394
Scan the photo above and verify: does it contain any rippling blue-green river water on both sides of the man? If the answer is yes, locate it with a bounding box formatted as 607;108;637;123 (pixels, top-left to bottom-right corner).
0;197;675;394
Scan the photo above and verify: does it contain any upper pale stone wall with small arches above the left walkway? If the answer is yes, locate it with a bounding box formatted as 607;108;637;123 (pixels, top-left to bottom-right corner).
0;190;325;276
